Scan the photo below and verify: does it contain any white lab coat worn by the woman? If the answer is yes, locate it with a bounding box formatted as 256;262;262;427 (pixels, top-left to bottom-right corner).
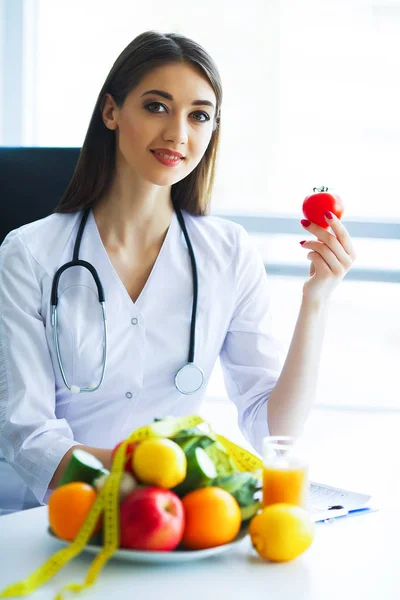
0;206;283;512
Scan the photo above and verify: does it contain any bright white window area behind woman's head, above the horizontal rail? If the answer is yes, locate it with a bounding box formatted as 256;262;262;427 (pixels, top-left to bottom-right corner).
14;0;400;219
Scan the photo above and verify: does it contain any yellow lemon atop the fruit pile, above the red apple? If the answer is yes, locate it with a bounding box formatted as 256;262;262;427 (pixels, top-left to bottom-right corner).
132;438;187;489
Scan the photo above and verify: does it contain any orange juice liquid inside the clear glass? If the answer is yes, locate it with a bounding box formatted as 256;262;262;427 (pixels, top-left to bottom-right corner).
262;463;308;508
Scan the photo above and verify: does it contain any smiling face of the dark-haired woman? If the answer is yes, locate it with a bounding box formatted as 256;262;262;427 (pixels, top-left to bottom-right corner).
103;63;216;186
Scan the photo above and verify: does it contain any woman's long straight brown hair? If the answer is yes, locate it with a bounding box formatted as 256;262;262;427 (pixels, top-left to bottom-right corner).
53;31;222;215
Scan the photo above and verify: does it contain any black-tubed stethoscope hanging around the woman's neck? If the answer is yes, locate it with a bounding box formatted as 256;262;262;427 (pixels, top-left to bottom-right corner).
51;203;204;394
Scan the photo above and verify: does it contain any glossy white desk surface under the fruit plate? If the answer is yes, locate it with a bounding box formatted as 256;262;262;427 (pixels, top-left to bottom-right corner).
0;507;400;600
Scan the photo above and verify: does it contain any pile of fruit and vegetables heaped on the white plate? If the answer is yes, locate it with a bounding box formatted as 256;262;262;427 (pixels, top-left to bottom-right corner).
48;418;262;551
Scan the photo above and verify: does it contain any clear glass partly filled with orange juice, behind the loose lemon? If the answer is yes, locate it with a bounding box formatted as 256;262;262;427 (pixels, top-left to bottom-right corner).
262;435;308;508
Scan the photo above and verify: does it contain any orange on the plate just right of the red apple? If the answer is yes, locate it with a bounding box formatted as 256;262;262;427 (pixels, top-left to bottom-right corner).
182;486;242;550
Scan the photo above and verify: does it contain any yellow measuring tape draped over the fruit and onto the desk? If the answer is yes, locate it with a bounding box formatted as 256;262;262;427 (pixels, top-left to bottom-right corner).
0;415;262;600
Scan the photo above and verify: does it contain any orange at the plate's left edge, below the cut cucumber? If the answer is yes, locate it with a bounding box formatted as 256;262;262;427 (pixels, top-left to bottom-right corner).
48;481;101;541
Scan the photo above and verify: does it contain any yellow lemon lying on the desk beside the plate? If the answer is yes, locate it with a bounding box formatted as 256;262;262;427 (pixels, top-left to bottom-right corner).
249;503;315;562
